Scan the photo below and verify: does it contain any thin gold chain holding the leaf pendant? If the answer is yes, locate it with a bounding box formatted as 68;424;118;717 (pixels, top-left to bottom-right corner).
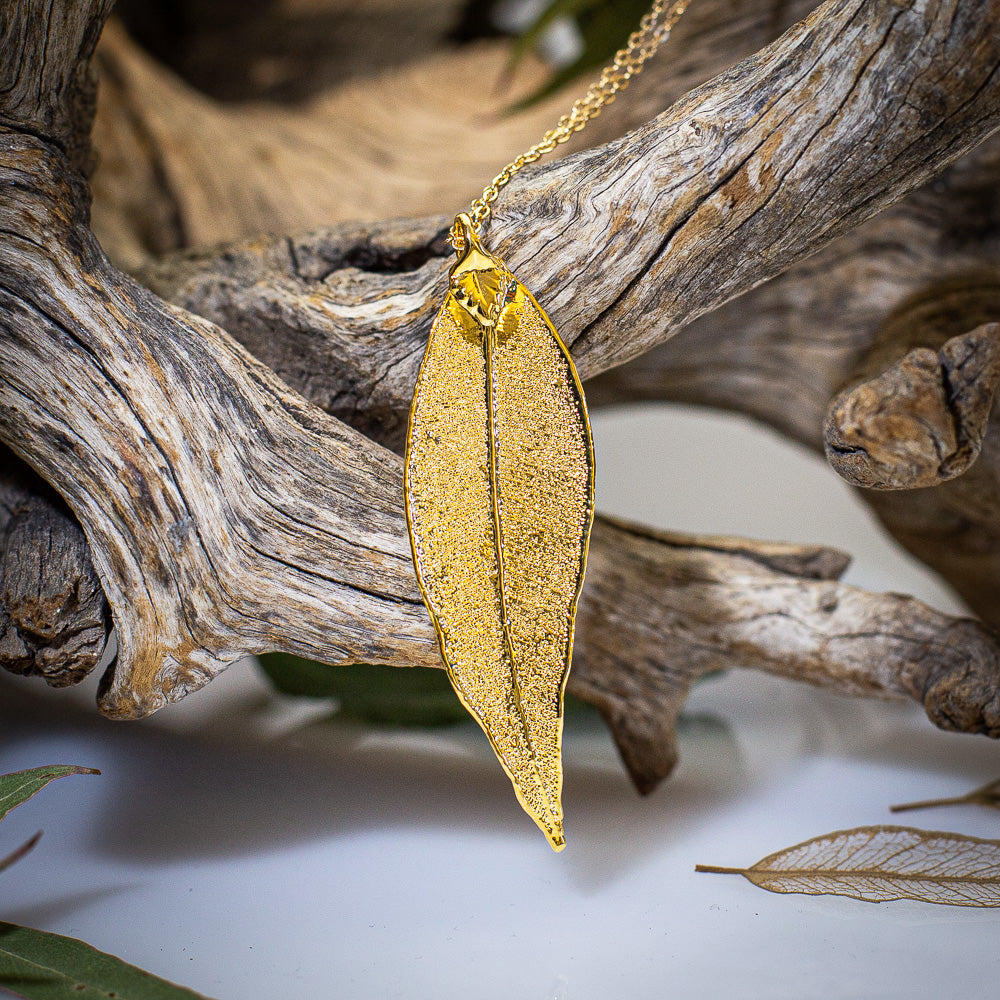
453;0;690;241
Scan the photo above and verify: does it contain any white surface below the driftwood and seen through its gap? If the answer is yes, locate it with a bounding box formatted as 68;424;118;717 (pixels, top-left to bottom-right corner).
0;408;1000;1000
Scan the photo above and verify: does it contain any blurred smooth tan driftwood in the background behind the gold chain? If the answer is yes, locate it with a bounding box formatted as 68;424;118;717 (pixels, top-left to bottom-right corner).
86;0;815;265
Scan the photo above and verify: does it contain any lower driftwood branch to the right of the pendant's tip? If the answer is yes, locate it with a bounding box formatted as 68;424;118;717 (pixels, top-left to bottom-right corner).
570;521;1000;791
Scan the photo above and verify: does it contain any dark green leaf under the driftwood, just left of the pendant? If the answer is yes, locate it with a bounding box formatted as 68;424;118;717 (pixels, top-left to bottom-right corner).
260;653;468;726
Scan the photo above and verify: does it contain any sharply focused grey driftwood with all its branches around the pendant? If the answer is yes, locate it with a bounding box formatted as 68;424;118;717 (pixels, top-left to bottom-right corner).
0;0;1000;785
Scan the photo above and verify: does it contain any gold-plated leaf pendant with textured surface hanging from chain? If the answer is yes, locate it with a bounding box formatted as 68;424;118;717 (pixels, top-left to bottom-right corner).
405;214;594;851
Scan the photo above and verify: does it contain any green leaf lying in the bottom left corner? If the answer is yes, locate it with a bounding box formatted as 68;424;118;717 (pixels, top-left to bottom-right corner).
0;923;217;1000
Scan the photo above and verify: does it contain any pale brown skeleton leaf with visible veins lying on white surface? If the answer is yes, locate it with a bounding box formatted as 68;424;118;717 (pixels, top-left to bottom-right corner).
695;826;1000;907
